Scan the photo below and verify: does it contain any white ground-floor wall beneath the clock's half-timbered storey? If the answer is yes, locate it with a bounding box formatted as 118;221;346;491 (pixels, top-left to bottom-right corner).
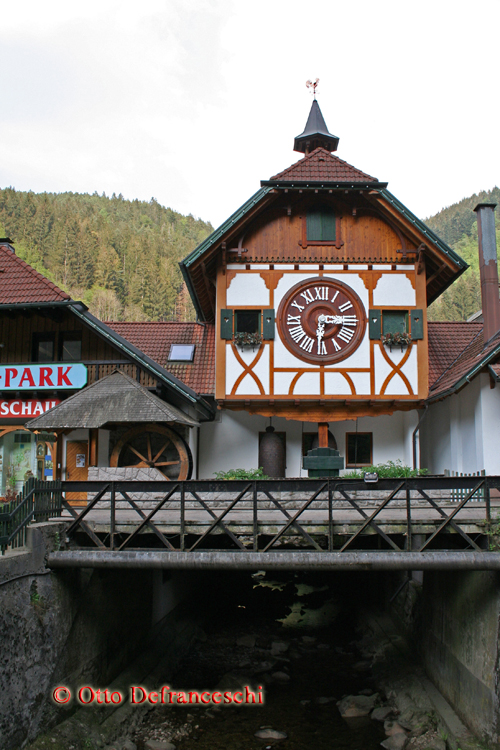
199;410;418;479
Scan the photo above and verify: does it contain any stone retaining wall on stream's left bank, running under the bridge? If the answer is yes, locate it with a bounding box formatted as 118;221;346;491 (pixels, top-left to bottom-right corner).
0;523;189;750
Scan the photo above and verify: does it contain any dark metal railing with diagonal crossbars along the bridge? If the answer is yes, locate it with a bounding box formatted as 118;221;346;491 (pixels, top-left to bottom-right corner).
34;476;500;553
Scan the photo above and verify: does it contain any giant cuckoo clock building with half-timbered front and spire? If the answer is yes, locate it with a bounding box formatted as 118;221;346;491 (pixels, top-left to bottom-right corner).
181;100;467;476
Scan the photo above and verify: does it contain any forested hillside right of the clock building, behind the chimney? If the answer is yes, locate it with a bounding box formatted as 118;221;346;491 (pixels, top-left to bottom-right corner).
425;187;500;320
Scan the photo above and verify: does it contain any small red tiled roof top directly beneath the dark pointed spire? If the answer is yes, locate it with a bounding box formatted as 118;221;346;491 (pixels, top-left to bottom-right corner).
271;148;378;182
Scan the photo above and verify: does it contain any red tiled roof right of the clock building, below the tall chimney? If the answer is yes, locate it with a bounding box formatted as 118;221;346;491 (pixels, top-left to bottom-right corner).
429;322;500;398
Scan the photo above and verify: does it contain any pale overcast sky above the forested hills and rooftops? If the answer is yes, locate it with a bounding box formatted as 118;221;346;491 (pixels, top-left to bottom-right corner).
0;0;500;226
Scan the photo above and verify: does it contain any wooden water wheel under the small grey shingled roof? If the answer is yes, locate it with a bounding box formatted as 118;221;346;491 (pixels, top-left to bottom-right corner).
110;424;193;480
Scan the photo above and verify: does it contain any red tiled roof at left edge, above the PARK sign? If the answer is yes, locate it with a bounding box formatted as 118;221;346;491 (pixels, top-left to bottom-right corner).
0;245;71;305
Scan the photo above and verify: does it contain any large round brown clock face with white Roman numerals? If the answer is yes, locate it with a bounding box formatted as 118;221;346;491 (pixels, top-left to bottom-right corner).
278;277;366;364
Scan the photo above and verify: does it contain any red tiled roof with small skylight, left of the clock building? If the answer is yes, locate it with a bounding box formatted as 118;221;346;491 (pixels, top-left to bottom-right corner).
106;321;215;396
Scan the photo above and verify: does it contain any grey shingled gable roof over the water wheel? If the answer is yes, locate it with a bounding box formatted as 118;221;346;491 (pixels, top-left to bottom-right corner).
26;370;198;430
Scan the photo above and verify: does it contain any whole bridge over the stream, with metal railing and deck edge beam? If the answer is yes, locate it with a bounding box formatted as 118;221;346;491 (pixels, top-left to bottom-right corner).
0;476;500;570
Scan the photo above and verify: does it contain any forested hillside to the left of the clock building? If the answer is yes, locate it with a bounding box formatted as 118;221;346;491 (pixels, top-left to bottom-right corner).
0;188;212;320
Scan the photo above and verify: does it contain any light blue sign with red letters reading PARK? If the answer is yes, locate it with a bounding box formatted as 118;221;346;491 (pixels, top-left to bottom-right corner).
0;363;87;391
